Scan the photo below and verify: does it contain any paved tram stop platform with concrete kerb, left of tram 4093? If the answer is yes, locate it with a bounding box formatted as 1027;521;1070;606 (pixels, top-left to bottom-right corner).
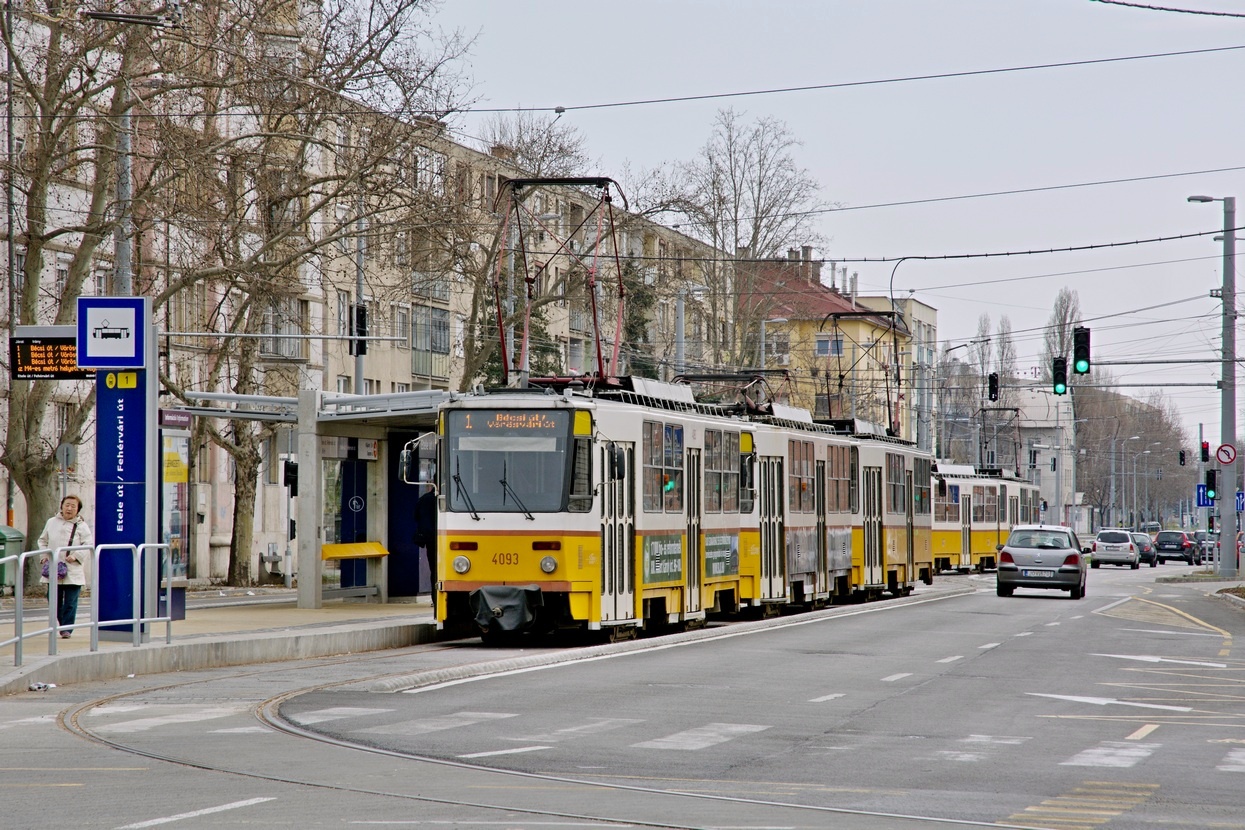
0;589;437;694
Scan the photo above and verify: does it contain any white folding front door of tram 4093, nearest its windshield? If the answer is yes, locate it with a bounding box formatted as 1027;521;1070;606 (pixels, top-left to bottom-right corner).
601;443;635;621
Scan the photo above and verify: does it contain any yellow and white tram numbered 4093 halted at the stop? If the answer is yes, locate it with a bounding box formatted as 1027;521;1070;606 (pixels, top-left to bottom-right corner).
418;378;934;636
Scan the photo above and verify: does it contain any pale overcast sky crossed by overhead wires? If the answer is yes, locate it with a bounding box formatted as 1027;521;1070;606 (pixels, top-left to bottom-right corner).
435;0;1245;444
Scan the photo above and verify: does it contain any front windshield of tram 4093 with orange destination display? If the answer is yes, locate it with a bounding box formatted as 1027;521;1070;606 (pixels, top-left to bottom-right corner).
446;409;570;514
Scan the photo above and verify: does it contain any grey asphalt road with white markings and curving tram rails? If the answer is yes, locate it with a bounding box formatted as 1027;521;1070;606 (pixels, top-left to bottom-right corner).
0;565;1245;830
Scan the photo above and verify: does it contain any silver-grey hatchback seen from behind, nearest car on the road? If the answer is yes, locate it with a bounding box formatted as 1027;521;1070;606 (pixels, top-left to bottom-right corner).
995;525;1089;600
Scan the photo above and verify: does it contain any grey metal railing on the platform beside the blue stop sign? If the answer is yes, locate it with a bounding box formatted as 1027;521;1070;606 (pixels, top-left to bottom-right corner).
0;544;173;666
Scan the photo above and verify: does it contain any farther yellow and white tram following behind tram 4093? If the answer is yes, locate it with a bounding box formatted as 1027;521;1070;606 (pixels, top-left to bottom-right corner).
934;462;1042;571
